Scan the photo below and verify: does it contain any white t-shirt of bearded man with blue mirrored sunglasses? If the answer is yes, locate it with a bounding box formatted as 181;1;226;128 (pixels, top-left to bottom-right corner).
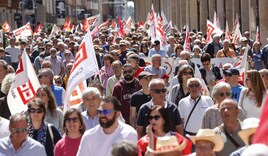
77;121;137;156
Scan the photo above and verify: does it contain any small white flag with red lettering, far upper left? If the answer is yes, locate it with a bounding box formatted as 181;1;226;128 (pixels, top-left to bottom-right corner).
13;22;33;39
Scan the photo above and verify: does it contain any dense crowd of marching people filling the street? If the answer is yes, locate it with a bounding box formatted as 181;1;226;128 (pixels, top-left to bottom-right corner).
0;22;268;156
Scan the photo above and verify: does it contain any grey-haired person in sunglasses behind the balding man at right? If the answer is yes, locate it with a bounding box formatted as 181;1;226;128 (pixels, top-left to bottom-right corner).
202;82;246;129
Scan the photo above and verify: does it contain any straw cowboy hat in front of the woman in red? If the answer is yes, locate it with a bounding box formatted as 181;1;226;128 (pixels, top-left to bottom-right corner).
147;136;186;154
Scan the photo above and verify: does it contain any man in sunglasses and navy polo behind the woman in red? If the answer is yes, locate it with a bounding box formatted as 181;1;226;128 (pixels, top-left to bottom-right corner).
137;79;182;139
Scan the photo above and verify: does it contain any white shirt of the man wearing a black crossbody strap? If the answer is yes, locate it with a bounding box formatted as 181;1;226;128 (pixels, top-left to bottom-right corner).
178;95;214;133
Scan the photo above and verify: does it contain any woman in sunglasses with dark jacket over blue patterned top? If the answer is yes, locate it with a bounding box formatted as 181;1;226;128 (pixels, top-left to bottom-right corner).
28;98;61;156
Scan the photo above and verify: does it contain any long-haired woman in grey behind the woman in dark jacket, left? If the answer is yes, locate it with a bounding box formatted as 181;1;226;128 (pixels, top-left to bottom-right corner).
36;85;63;134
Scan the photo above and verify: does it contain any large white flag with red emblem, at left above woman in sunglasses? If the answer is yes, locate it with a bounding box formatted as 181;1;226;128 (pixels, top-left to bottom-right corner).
7;51;40;114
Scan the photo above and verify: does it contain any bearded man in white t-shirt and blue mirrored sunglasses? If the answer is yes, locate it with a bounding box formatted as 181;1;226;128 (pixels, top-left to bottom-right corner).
77;97;137;156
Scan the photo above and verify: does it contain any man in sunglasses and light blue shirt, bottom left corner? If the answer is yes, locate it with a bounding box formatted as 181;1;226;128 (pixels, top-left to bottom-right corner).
0;113;46;156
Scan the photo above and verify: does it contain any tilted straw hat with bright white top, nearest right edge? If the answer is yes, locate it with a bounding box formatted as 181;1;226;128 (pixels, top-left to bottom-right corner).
238;118;260;145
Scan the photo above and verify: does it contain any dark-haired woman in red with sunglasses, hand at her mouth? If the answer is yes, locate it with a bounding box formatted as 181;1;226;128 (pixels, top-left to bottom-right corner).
138;105;192;156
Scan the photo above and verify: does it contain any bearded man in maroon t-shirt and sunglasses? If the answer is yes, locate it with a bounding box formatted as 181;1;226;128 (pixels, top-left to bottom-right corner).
112;63;141;124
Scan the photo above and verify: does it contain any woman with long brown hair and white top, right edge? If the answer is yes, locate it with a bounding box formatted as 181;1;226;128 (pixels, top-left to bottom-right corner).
238;70;266;118
